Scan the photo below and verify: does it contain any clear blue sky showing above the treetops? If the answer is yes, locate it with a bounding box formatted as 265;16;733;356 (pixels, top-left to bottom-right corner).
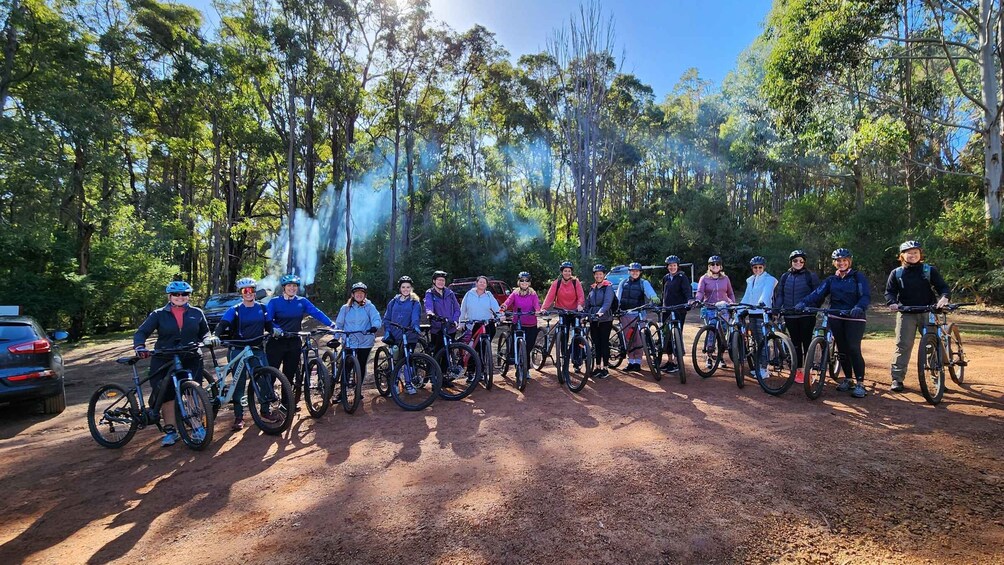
184;0;771;100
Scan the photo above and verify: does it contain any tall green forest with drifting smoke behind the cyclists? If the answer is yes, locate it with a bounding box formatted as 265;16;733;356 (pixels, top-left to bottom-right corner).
0;0;1004;338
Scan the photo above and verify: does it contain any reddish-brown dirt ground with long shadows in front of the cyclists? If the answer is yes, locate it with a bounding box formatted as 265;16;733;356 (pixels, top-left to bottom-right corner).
0;314;1004;564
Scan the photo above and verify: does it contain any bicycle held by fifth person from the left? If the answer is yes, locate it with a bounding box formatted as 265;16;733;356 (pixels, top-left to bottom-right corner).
373;320;443;410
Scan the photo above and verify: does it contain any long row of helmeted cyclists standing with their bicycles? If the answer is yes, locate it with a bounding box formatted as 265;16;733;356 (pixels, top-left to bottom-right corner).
134;241;950;446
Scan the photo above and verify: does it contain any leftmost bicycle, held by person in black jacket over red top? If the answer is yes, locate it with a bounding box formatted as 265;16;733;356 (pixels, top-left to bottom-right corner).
87;343;215;451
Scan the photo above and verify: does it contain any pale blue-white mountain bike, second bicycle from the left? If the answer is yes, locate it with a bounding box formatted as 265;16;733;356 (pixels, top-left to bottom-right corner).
202;337;293;436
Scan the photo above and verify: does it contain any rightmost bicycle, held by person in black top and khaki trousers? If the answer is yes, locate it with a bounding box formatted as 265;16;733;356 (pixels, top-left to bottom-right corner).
899;304;971;404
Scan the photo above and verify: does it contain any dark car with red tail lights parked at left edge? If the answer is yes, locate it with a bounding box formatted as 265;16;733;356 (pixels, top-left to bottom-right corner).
0;316;67;413
